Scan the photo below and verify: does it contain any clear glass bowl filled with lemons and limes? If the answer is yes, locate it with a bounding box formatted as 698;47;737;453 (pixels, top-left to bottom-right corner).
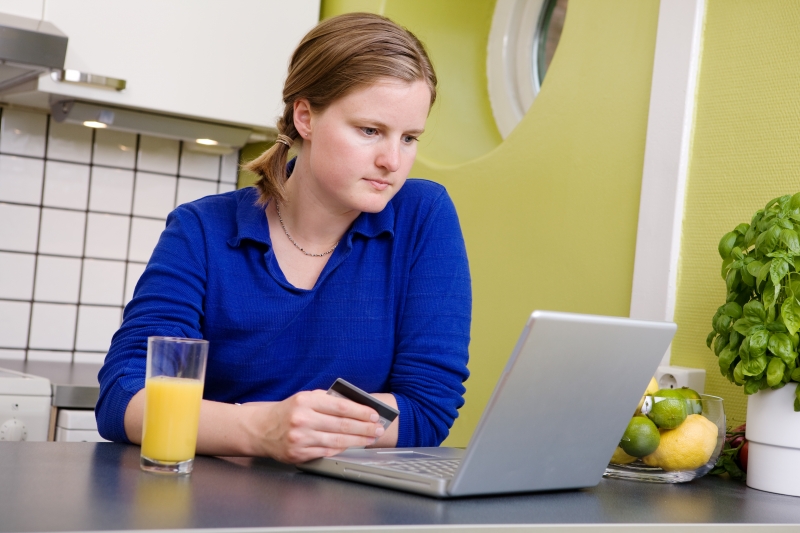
604;391;725;483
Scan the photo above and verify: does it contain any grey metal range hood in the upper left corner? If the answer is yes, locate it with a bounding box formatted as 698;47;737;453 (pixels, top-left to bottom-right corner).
0;14;67;91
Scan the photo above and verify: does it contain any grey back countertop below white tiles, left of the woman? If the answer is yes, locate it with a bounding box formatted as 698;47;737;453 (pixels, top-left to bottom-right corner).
0;360;102;409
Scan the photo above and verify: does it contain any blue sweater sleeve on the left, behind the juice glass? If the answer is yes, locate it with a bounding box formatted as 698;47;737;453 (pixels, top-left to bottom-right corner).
95;207;207;442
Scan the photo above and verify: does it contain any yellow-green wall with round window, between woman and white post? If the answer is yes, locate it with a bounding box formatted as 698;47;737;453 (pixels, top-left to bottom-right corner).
322;0;658;446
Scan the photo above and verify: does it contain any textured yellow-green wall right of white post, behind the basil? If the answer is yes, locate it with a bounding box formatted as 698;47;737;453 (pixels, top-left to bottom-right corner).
672;0;800;426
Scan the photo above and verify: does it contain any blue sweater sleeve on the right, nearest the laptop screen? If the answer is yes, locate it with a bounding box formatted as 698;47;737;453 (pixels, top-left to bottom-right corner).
390;191;472;447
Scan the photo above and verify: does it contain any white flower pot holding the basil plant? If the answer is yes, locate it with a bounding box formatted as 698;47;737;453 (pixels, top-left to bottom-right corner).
746;382;800;496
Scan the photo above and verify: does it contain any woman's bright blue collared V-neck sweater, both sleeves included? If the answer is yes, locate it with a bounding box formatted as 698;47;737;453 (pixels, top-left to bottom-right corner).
96;180;472;446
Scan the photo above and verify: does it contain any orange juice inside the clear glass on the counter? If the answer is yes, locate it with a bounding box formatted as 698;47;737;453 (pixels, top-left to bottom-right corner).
142;376;203;462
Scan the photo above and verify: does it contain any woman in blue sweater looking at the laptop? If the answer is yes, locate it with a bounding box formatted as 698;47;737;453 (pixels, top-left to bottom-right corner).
96;13;471;463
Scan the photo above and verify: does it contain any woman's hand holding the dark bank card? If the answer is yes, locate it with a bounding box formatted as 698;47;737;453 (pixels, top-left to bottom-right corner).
245;390;384;463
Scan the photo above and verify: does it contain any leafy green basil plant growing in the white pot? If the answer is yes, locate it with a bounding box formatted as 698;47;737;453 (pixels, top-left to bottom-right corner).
706;193;800;411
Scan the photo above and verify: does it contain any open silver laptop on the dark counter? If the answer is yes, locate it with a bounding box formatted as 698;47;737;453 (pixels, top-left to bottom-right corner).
298;311;677;498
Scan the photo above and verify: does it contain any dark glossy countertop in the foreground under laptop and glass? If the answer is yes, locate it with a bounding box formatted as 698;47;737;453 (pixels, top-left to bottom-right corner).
0;442;800;533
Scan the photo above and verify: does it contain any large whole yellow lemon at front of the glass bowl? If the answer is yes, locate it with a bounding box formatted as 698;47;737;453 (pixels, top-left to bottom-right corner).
642;414;719;471
